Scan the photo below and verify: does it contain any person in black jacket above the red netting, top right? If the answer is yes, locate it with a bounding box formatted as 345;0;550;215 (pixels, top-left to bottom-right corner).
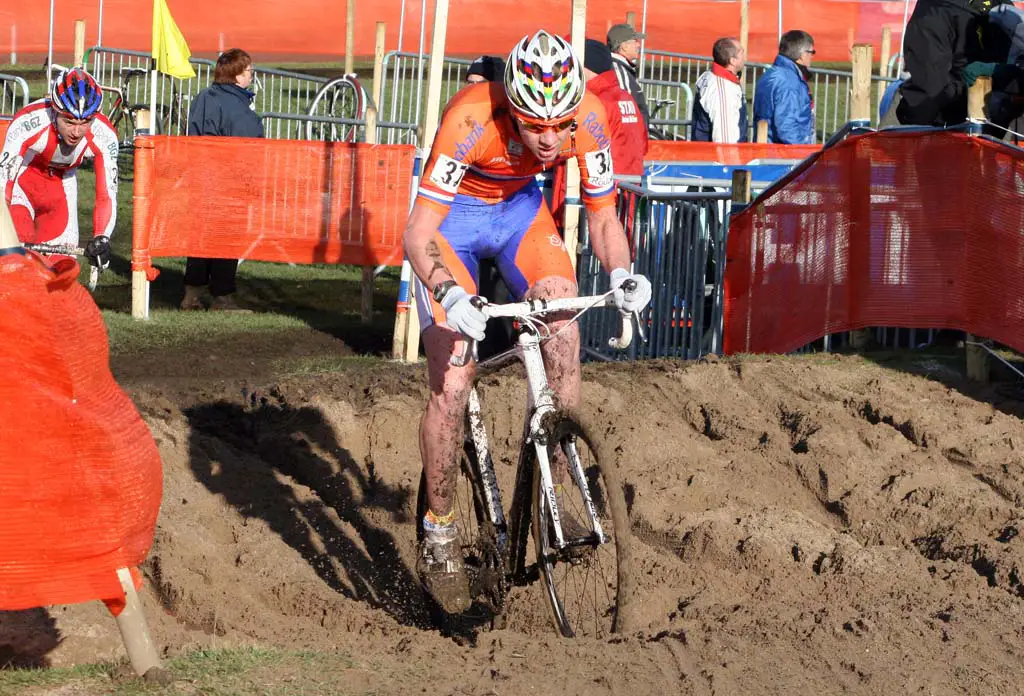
895;0;1010;127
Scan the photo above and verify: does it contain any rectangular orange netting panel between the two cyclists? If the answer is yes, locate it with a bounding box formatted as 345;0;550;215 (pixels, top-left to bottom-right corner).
132;136;415;277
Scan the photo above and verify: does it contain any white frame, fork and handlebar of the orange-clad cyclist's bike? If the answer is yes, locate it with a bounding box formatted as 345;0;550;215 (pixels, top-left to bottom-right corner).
452;293;633;570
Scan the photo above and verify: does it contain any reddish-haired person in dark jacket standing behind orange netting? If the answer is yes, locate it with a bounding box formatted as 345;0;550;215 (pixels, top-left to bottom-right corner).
181;48;263;311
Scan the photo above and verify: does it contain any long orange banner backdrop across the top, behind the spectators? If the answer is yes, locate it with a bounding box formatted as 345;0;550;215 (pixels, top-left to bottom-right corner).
0;0;914;62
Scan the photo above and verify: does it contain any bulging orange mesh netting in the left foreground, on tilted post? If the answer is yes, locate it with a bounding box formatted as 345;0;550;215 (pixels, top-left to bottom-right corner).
0;249;162;610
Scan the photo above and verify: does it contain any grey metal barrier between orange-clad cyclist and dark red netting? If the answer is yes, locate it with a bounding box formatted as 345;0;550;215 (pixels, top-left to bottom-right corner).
579;183;730;360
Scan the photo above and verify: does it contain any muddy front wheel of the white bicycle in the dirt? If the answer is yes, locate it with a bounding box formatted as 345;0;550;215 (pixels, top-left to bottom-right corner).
532;415;630;639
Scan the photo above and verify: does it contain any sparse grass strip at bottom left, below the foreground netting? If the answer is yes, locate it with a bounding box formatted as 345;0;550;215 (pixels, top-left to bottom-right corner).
0;647;387;696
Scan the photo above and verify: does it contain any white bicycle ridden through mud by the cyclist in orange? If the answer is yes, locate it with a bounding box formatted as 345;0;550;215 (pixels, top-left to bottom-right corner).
417;281;633;638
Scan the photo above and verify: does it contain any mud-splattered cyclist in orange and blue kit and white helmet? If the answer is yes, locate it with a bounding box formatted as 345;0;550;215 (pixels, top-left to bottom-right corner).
404;31;651;613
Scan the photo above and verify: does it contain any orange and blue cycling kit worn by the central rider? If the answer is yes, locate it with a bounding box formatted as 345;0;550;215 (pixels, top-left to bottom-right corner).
416;83;615;329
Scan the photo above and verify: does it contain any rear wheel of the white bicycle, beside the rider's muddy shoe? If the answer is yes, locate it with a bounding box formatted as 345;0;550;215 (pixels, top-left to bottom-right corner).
416;433;506;630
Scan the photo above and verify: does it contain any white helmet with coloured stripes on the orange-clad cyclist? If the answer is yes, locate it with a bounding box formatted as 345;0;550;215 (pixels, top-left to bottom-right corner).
505;30;586;123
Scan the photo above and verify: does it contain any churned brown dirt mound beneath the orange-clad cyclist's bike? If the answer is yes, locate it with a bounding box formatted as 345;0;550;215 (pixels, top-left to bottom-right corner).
0;356;1024;694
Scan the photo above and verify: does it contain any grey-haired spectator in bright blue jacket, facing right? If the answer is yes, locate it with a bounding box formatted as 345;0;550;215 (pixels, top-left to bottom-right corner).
754;29;814;145
